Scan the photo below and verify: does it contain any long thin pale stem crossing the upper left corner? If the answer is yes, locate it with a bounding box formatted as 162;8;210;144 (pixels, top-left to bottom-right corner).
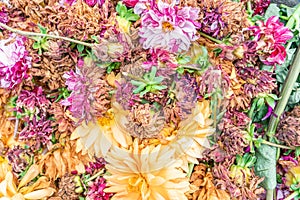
0;22;94;47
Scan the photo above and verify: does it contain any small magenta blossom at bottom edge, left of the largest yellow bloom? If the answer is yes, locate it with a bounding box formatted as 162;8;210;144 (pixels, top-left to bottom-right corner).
86;177;112;200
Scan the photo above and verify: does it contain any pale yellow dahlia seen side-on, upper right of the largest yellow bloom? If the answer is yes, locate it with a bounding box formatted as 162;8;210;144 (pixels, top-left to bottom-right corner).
170;101;215;164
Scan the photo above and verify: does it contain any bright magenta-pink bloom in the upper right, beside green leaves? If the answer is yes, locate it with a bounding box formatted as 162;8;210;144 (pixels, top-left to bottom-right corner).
249;16;293;65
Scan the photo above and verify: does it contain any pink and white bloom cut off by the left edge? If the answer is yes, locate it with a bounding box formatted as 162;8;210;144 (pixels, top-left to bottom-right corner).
0;36;31;89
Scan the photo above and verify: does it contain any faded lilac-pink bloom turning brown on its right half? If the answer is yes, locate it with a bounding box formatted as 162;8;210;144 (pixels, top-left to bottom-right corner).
61;61;110;123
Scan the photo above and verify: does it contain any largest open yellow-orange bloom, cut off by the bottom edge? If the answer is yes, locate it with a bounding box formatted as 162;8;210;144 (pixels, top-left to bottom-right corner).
104;140;189;200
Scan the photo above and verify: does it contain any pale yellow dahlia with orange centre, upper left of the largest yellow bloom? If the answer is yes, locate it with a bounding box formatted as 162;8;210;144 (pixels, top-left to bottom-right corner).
71;105;132;158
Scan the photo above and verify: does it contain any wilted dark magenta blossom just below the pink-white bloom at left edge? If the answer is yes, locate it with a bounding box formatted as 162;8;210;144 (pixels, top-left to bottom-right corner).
16;86;50;114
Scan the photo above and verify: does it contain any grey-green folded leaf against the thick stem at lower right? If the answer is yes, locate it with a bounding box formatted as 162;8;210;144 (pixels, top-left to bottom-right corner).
255;144;277;190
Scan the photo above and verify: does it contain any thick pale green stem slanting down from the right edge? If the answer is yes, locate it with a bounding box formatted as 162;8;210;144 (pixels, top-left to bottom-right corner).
267;48;300;137
